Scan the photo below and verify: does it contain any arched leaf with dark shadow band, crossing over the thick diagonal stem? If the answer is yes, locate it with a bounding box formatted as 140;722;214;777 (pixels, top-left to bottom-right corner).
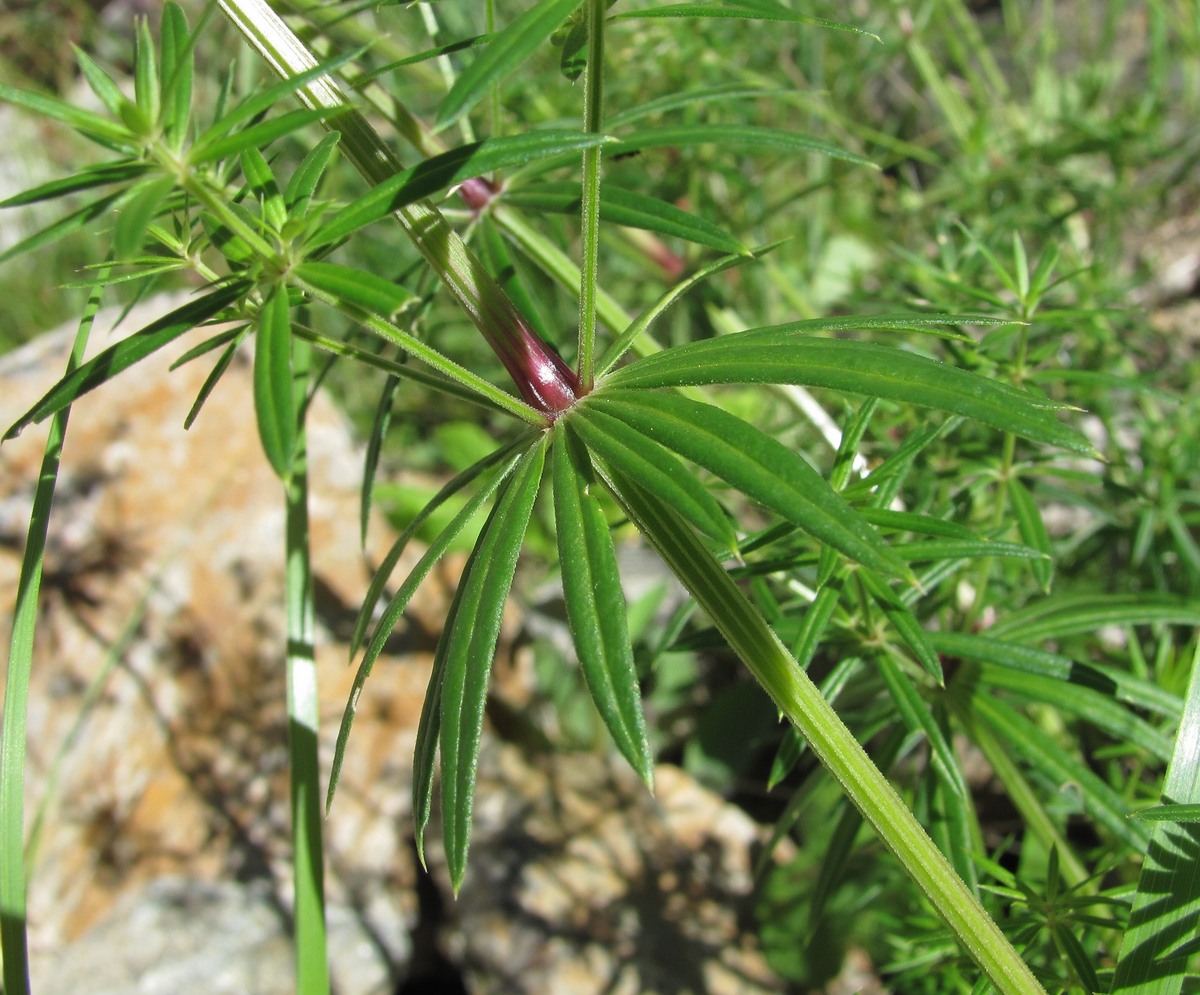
310;128;613;246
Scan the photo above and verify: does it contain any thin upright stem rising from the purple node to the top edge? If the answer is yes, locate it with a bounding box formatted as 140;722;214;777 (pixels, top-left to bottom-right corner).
576;0;608;392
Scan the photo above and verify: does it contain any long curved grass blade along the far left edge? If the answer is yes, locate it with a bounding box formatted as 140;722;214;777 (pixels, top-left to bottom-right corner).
0;279;107;995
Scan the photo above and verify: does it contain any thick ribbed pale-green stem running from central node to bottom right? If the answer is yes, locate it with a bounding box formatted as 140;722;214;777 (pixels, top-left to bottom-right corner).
613;480;1044;995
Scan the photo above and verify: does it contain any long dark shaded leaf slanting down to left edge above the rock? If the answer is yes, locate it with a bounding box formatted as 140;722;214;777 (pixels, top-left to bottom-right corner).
4;282;248;439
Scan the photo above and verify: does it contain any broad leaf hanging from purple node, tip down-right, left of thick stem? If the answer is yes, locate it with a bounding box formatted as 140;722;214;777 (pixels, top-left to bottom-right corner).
552;425;654;785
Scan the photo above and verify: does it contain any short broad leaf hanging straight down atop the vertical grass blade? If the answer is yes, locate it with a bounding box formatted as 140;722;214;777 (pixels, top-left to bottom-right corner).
254;287;296;480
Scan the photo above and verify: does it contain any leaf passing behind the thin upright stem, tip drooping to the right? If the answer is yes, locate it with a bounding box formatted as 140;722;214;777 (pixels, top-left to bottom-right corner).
504;182;749;256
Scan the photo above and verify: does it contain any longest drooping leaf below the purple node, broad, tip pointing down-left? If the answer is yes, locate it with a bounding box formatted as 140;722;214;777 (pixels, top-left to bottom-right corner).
436;436;548;892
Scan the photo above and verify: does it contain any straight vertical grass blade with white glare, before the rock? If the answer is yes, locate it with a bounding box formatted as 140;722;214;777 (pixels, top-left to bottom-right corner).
284;340;329;995
